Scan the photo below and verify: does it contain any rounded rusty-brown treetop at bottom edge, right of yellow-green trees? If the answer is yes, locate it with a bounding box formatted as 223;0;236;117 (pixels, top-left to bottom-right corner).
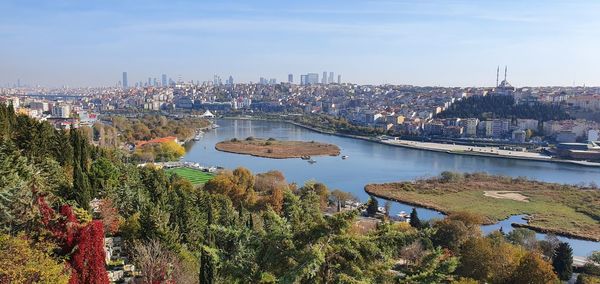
511;252;558;284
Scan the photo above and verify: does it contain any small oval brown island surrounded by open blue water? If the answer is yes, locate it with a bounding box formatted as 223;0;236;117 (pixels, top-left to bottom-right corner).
215;137;340;159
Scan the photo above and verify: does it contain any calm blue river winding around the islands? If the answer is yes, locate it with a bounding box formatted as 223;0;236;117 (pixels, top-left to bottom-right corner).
184;119;600;256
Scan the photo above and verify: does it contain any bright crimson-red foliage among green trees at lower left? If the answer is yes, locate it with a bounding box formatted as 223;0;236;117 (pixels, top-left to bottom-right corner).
38;197;108;284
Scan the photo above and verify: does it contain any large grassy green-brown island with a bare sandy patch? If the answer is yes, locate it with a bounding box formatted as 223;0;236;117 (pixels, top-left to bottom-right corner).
365;172;600;241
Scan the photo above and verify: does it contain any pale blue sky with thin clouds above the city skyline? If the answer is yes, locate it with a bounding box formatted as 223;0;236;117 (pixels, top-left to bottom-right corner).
0;0;600;87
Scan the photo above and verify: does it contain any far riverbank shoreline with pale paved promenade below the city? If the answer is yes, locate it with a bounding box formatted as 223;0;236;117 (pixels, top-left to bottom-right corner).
221;117;600;168
